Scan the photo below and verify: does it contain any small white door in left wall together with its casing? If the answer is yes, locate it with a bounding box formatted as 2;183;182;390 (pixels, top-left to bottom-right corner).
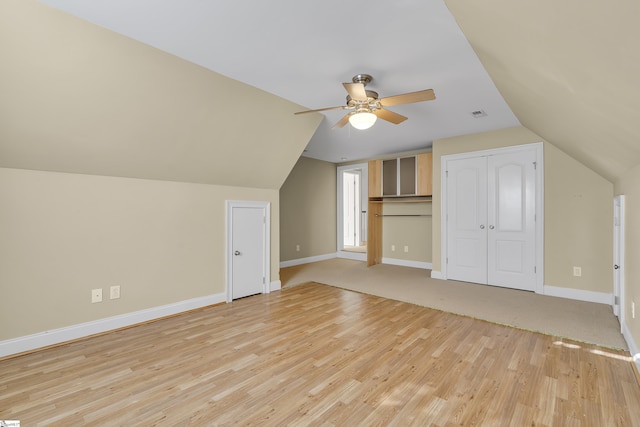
226;201;271;302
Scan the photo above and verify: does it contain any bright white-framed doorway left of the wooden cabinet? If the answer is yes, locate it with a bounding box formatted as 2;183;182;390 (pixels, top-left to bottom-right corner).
337;163;368;261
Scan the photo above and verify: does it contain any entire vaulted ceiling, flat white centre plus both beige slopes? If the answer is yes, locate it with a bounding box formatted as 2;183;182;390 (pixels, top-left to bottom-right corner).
0;0;640;188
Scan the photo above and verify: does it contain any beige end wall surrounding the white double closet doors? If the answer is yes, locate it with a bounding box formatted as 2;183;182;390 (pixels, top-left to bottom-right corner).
433;127;613;293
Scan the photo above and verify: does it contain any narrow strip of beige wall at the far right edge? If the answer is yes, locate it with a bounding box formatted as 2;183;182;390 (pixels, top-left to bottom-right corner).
615;165;640;356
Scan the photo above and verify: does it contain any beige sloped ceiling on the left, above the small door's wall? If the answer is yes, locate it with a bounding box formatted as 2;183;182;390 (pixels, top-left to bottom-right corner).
0;0;321;189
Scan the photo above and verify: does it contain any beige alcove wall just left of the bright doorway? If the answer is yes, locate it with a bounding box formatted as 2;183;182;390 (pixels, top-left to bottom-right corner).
280;157;337;261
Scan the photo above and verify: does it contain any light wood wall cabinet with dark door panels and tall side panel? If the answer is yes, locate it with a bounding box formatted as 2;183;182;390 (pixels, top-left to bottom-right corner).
367;153;433;266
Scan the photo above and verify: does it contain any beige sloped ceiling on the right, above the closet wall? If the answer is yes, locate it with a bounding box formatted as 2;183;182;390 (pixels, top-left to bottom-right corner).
446;0;640;181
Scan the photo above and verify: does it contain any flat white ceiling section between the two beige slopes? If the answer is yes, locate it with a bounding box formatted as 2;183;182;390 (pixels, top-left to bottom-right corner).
42;0;519;163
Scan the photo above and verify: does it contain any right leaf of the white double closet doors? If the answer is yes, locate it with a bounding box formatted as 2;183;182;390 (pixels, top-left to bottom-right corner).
487;151;536;291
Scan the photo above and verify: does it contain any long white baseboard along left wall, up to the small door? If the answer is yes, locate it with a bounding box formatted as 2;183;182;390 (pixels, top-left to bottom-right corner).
0;293;226;357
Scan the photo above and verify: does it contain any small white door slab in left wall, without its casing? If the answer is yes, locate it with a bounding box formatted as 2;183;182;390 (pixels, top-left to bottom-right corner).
227;206;267;299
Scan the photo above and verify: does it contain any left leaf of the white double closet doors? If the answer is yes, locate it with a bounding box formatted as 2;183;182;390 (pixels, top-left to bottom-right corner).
446;157;487;284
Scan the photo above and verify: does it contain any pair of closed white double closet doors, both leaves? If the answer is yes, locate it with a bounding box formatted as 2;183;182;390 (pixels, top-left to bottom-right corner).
446;151;536;291
